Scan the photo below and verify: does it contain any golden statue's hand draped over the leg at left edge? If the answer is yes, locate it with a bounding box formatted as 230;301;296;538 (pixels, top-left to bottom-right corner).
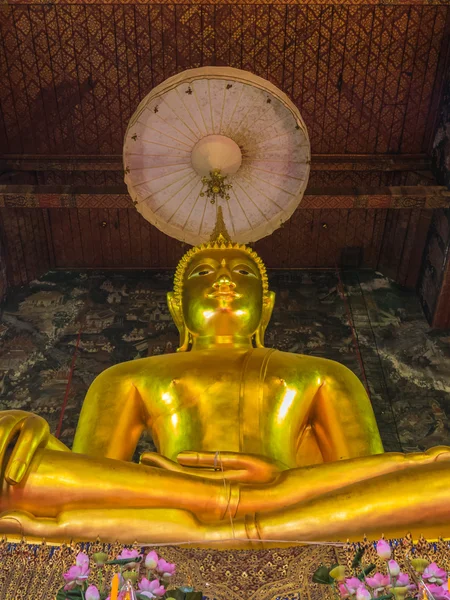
0;410;67;485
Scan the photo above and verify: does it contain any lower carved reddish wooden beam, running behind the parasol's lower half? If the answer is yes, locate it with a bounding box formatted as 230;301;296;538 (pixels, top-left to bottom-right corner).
0;185;450;210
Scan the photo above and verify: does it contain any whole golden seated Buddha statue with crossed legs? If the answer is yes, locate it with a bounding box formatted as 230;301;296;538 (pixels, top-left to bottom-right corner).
0;224;450;546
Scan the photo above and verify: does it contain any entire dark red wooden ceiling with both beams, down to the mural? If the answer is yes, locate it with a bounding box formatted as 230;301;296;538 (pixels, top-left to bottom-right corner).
0;0;450;286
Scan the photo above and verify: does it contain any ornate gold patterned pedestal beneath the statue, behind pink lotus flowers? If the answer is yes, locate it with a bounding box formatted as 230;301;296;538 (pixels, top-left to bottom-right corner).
0;538;450;600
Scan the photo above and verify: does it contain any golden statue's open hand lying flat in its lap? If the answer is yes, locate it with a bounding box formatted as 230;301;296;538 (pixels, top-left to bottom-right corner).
141;451;286;483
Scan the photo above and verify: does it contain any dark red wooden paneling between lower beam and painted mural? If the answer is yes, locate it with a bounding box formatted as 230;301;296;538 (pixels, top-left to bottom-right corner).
0;208;429;287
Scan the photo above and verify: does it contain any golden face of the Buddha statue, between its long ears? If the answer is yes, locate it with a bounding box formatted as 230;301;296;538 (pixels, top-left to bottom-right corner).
182;249;263;337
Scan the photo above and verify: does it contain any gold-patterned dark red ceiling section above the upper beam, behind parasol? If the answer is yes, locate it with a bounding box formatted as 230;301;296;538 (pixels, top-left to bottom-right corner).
0;0;449;155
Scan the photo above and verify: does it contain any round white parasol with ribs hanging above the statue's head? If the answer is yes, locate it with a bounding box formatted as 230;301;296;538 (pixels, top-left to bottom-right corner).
124;67;310;245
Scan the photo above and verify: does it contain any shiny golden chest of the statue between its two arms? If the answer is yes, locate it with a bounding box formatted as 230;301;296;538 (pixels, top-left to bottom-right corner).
144;349;312;462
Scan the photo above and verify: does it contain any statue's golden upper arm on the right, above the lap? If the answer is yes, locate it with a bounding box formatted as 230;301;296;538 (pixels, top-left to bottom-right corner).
311;363;383;462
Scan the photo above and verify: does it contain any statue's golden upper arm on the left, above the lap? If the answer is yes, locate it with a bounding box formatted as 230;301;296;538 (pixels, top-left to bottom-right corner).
72;363;147;460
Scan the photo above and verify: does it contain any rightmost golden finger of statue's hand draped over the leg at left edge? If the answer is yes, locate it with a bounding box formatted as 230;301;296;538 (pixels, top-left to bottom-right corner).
5;415;50;485
